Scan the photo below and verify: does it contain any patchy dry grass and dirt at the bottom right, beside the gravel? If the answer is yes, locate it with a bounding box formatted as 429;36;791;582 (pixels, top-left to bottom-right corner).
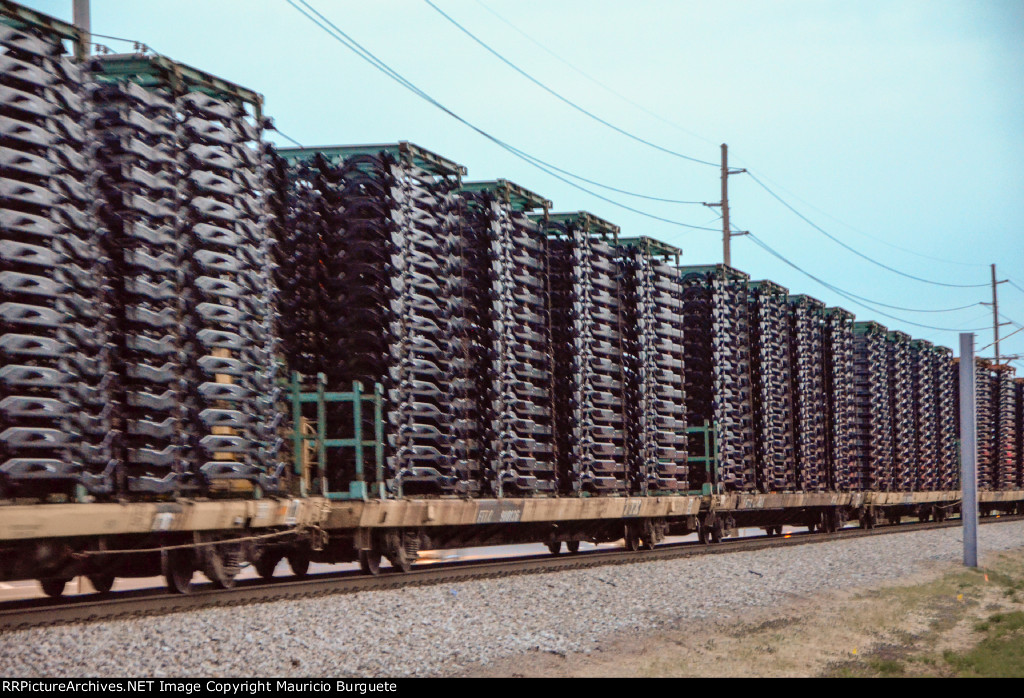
469;551;1024;677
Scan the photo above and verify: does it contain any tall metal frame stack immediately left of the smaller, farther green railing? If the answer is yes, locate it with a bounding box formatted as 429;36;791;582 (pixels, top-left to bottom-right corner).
618;237;689;493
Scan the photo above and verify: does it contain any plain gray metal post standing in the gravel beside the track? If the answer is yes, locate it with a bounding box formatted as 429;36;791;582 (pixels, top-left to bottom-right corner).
959;332;978;567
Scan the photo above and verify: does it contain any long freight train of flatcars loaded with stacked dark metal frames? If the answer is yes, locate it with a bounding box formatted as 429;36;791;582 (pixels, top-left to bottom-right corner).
0;2;1024;596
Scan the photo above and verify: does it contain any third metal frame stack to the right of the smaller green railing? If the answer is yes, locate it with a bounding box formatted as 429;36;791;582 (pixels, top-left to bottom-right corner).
790;296;827;492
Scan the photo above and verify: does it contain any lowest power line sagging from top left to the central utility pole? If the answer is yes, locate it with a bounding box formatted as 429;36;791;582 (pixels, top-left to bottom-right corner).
286;0;717;232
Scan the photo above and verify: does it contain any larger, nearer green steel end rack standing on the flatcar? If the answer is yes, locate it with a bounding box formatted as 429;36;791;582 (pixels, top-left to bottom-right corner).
289;372;384;499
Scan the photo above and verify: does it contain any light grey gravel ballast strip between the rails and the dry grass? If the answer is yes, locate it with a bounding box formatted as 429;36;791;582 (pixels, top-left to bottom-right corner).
0;522;1024;677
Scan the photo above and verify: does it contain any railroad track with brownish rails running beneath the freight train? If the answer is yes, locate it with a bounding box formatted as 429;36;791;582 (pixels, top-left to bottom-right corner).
0;516;1024;631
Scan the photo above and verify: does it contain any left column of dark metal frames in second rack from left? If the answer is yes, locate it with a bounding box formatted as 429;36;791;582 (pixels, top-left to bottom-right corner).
90;70;182;493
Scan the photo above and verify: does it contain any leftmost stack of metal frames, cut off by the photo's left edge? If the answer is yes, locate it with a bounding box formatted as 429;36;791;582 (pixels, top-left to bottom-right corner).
0;12;116;496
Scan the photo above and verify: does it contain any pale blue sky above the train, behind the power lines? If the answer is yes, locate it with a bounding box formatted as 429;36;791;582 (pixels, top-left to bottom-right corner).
28;0;1024;366
